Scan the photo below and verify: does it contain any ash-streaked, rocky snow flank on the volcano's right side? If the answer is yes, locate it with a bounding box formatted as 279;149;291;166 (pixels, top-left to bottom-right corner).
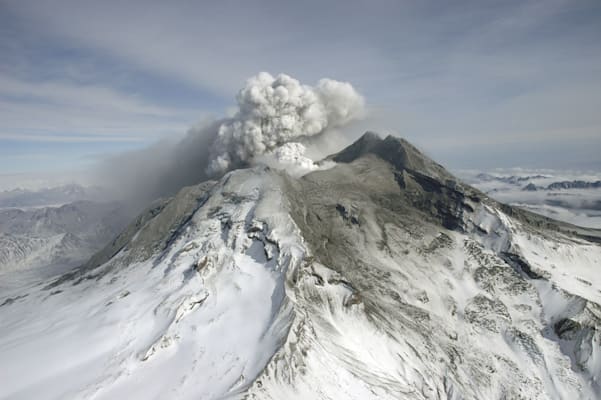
251;142;601;399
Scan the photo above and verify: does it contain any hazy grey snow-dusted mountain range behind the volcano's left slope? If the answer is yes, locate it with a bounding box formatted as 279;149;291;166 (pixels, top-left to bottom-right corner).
0;201;127;273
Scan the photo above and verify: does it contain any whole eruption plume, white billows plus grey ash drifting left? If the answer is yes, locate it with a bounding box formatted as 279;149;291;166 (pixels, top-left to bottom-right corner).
94;72;365;212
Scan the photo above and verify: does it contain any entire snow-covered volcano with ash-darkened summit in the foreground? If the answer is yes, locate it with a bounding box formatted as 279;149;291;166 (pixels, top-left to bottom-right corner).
0;133;601;399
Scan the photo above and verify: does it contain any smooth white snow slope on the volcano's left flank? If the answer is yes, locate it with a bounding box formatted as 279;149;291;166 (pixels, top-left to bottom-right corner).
0;167;304;399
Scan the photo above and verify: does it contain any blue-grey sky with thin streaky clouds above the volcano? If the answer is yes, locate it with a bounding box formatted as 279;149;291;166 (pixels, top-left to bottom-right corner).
0;0;601;180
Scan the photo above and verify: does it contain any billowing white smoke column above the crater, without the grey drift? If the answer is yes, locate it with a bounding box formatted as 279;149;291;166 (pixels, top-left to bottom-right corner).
207;72;365;175
